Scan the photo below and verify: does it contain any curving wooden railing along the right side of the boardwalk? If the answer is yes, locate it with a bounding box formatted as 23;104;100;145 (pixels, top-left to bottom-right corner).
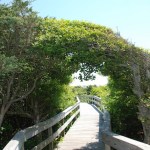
87;96;150;150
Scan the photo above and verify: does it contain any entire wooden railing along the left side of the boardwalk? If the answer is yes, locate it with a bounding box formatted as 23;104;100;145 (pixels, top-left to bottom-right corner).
3;98;80;150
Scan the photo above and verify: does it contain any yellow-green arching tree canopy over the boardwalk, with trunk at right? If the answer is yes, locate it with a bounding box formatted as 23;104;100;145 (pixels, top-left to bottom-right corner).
35;19;150;143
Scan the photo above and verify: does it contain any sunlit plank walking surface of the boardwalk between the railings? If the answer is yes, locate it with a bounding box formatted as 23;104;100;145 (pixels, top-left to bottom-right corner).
56;103;103;150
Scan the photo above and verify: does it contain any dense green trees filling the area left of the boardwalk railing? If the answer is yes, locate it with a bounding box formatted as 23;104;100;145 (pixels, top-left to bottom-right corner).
0;0;75;149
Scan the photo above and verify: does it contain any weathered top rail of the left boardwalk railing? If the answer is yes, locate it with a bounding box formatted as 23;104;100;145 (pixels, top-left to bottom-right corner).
3;101;80;150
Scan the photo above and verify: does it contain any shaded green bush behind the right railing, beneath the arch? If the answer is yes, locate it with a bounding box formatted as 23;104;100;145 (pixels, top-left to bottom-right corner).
105;80;143;141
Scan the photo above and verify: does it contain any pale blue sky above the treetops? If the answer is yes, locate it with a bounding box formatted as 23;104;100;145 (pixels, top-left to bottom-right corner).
0;0;150;86
